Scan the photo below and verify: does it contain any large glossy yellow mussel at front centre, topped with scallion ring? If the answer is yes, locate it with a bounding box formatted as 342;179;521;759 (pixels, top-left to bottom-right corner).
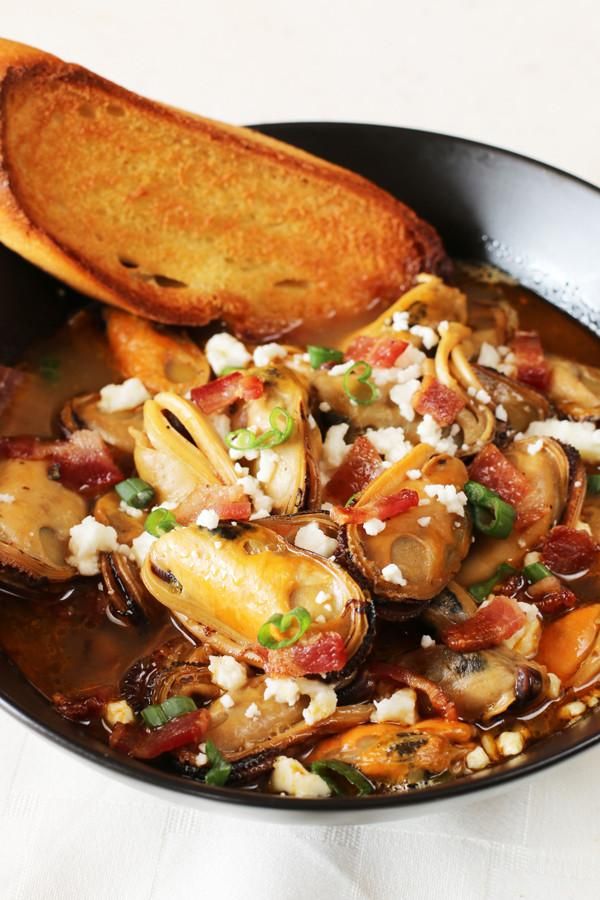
142;523;372;678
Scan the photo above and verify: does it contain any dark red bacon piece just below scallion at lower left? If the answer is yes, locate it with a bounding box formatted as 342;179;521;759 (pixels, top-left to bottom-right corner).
108;709;210;759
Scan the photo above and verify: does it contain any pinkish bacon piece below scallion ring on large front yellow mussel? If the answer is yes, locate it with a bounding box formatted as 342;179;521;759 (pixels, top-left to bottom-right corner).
265;631;348;678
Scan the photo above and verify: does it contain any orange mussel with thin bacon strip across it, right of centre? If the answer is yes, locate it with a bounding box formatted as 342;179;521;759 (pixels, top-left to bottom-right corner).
341;444;471;601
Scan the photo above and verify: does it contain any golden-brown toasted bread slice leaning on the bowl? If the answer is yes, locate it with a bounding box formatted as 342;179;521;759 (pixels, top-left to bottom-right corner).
0;40;447;339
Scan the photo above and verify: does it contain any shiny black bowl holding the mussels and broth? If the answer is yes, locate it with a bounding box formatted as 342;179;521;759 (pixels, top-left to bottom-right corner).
0;122;600;821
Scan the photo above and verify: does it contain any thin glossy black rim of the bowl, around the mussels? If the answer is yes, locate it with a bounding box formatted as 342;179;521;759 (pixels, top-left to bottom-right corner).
0;120;600;814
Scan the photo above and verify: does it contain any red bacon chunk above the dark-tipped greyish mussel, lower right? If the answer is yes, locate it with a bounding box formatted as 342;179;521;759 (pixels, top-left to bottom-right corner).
442;594;527;653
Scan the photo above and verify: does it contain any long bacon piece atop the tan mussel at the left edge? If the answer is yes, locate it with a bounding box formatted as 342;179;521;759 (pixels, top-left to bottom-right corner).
0;429;124;493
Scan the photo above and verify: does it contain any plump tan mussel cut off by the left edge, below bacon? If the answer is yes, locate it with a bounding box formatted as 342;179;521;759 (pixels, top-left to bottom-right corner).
0;459;87;581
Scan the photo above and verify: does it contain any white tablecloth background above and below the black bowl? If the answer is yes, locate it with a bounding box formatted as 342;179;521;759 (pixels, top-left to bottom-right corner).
0;0;600;900
